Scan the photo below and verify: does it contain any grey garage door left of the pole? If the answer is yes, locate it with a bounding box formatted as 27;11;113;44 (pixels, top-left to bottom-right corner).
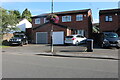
36;32;48;44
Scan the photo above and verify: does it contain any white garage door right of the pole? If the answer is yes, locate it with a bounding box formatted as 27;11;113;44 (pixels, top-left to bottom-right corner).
53;31;64;44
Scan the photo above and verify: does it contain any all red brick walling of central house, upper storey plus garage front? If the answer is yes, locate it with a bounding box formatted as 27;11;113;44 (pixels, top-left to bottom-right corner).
32;10;92;43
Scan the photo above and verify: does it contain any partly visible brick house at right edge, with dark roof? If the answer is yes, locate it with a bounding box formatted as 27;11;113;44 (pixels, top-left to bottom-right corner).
99;9;120;35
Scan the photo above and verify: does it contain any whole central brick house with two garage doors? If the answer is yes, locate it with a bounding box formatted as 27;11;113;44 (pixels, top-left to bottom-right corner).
32;9;92;44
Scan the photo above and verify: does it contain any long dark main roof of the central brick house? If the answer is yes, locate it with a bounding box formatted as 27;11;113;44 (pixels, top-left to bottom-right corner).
32;9;91;18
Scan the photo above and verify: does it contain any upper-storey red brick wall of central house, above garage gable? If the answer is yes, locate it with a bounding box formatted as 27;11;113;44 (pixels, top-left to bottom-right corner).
32;11;92;37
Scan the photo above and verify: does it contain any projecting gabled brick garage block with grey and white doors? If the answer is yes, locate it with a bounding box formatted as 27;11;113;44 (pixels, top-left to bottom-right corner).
33;23;72;45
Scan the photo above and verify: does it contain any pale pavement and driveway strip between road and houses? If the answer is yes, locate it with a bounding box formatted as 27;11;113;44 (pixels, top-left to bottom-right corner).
2;44;120;60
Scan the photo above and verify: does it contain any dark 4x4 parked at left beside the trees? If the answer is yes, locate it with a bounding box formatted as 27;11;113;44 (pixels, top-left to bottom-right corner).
9;33;28;46
